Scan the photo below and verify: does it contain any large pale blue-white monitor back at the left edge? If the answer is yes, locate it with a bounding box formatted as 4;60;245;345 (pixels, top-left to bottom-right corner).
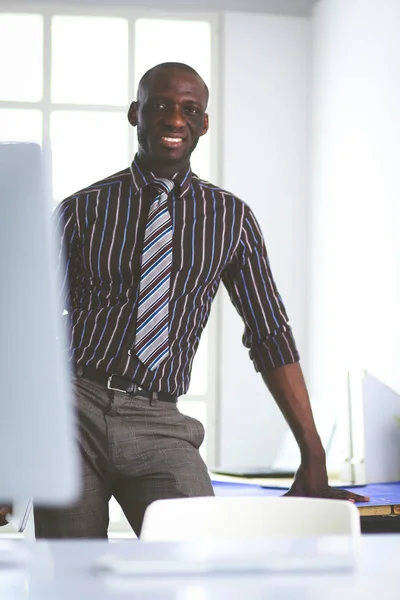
0;143;79;505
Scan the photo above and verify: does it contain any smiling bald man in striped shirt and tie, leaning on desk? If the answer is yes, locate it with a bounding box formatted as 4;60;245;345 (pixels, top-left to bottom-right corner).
0;63;365;537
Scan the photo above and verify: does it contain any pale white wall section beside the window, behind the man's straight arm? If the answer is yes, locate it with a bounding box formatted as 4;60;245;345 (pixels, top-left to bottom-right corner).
219;13;310;465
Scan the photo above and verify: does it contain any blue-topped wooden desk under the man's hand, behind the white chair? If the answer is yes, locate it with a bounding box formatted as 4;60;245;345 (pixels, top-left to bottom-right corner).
212;475;400;533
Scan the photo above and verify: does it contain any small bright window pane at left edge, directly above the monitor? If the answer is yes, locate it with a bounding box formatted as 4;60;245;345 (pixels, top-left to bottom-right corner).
0;108;42;144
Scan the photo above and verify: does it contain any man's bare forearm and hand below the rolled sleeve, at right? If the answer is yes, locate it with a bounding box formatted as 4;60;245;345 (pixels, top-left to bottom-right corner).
261;362;369;502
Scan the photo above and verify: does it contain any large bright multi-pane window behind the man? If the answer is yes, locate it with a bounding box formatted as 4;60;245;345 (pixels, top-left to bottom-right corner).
0;2;217;531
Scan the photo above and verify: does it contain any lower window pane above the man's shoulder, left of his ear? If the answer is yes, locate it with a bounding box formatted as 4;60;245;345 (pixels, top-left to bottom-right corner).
50;111;129;200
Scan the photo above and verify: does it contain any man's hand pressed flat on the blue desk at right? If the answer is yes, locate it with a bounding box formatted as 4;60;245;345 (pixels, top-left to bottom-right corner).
285;458;369;502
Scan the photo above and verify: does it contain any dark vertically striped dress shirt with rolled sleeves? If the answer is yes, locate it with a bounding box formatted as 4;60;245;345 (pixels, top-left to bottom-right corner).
54;158;299;396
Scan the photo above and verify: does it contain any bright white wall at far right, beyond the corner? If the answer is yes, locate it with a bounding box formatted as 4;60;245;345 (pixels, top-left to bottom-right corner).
309;0;400;464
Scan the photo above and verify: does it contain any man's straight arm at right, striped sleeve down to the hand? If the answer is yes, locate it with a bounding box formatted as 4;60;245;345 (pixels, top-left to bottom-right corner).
222;206;368;501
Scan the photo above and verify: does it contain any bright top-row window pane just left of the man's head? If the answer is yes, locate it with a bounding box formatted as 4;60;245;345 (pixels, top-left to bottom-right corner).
51;16;128;106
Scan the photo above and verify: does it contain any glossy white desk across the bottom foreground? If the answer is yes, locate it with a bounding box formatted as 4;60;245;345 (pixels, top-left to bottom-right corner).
0;534;400;600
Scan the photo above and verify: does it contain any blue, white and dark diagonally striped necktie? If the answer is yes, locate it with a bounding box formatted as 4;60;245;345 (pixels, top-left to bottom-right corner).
135;179;174;369
